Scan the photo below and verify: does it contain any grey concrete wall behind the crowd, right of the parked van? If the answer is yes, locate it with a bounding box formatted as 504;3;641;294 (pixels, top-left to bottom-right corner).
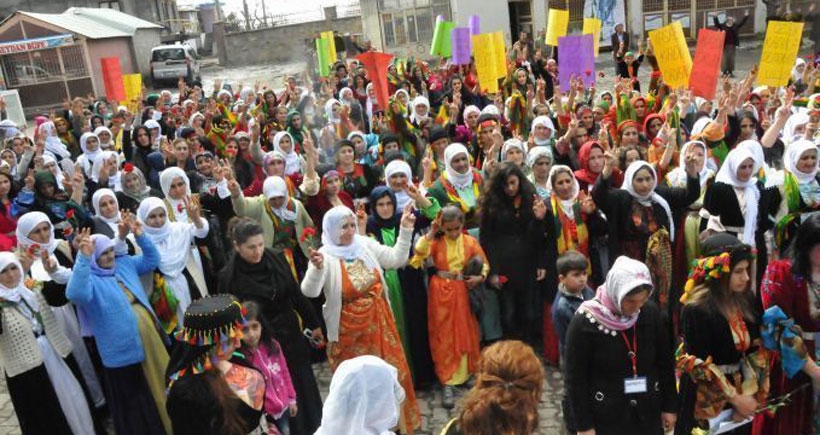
217;17;362;66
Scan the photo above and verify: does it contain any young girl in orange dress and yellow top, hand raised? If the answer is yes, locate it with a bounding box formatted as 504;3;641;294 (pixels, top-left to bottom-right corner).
410;205;490;409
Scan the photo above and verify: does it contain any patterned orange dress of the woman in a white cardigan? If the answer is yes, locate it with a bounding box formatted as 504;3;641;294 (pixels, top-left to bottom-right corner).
327;260;421;434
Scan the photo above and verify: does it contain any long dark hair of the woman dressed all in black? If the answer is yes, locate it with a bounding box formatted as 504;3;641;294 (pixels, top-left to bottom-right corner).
479;162;535;232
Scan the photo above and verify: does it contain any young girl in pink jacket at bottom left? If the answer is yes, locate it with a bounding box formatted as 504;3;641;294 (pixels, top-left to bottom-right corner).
240;301;298;435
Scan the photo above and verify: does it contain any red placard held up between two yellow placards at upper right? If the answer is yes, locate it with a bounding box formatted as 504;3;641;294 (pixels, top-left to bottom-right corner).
689;29;726;100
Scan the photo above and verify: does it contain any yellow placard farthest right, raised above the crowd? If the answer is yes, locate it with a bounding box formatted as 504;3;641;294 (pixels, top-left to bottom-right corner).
757;21;803;86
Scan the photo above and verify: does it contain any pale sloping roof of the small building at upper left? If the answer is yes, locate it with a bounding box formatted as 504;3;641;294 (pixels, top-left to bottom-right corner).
19;8;162;39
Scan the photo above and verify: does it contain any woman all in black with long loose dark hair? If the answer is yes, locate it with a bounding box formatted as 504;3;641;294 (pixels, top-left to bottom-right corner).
480;163;547;344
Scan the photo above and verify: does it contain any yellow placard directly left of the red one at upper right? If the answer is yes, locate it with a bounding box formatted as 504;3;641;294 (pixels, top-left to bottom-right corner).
649;21;692;89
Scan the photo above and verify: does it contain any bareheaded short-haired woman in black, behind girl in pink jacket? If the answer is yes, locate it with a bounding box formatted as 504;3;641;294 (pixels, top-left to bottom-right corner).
219;218;323;435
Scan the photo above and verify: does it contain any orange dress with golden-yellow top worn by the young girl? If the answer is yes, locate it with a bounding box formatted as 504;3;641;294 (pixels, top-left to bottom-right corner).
427;235;487;385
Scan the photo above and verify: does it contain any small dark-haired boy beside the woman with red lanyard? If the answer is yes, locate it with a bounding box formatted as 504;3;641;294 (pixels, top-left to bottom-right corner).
552;250;595;365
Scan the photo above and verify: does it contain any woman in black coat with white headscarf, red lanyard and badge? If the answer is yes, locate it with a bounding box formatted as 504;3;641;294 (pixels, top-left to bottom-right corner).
565;257;678;435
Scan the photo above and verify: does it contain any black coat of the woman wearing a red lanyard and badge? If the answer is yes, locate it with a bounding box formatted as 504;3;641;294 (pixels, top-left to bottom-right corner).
565;301;678;435
